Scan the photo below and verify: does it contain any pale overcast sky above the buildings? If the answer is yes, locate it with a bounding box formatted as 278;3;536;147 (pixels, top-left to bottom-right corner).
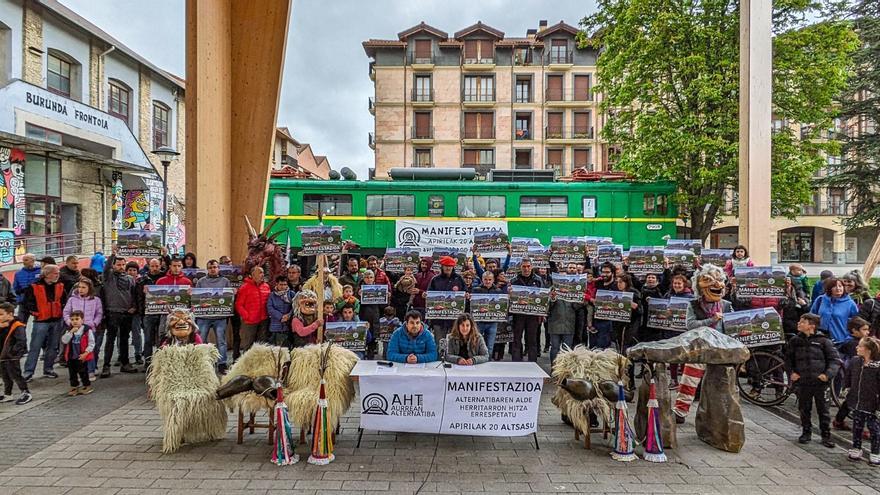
61;0;595;179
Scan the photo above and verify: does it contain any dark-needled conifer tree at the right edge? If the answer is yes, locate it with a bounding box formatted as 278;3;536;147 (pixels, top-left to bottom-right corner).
825;0;880;229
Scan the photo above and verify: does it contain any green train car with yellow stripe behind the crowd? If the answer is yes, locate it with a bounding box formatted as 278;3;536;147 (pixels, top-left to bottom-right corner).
264;178;678;253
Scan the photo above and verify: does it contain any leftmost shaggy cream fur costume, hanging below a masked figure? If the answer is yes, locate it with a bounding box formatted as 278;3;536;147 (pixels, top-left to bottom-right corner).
147;344;227;454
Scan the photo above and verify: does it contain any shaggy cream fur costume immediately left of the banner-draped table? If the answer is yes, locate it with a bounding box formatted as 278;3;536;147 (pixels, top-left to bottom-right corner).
284;344;358;429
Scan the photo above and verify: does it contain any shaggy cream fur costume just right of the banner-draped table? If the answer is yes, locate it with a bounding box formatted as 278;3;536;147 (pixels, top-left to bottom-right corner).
552;345;629;435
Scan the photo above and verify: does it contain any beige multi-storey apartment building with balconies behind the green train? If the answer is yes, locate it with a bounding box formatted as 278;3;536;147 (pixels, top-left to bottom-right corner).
363;21;609;179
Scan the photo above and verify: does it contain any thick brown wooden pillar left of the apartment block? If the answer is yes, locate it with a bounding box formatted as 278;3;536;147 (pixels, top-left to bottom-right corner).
186;0;291;263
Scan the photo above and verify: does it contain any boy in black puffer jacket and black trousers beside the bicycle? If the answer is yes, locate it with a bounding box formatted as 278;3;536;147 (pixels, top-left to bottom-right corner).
785;313;840;449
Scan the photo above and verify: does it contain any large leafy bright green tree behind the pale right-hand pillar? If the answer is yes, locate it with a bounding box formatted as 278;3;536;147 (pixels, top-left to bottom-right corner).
579;0;857;240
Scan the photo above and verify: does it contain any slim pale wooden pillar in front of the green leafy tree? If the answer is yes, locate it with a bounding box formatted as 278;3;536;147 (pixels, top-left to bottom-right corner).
739;0;775;265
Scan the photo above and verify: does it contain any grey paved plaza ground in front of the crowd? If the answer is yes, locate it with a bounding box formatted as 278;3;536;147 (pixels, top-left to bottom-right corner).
0;358;880;495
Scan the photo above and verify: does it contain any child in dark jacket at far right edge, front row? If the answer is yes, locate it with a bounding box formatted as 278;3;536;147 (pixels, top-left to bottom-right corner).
845;337;880;467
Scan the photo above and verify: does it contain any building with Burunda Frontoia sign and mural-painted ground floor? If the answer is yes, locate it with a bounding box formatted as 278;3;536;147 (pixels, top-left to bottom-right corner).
0;0;186;255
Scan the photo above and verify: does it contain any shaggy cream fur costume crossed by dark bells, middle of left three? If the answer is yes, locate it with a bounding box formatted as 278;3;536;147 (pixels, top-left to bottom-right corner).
223;344;290;416
